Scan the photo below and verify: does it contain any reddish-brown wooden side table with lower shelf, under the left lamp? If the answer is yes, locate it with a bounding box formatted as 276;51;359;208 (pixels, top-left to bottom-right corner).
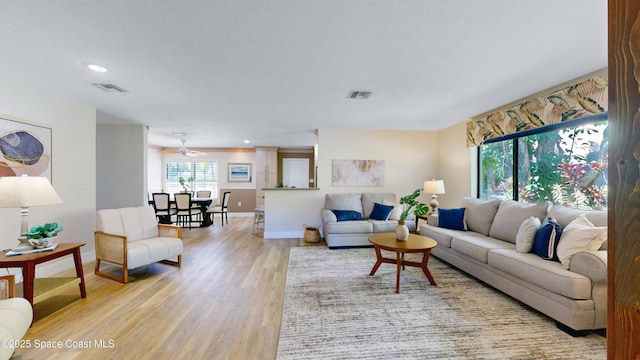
0;243;87;305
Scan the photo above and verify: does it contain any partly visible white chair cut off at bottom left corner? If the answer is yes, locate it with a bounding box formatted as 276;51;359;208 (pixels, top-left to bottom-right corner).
0;275;33;360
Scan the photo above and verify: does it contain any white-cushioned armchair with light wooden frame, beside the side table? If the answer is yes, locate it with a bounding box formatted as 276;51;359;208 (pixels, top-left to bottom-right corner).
95;206;183;283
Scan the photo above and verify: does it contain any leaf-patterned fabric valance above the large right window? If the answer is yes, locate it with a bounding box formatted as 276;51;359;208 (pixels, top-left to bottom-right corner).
467;75;609;147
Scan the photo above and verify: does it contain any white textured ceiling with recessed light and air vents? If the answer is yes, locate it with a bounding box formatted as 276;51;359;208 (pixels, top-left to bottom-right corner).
0;0;607;147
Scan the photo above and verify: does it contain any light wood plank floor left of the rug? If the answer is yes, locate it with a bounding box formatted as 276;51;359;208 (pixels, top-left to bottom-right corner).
15;217;324;360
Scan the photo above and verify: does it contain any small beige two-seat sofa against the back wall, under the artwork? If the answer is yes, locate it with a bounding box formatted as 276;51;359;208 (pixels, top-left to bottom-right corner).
320;193;416;248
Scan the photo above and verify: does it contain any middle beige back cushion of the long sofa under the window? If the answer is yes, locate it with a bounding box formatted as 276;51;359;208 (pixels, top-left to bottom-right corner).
489;200;547;244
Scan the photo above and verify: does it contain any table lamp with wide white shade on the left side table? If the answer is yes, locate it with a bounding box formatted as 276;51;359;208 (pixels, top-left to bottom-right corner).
0;175;63;251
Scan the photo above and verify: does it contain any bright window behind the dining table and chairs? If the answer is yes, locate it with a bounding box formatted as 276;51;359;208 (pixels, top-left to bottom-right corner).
163;161;218;196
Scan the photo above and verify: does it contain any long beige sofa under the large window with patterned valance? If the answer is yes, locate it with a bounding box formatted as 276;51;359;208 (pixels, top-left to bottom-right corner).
420;198;607;335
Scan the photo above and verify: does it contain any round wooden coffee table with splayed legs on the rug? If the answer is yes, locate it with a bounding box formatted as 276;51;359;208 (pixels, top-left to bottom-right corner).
369;233;438;294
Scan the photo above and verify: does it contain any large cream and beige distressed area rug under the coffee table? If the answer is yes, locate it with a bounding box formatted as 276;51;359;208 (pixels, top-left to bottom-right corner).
277;247;606;360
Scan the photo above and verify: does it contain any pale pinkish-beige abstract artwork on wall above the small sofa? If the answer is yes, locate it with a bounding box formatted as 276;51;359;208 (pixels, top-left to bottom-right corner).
331;160;384;186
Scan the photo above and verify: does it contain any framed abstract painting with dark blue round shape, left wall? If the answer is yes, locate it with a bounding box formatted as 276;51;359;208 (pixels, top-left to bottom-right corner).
0;117;51;181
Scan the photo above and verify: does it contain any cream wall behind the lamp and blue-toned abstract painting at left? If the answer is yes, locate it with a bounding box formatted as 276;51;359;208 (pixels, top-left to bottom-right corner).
0;73;96;278
